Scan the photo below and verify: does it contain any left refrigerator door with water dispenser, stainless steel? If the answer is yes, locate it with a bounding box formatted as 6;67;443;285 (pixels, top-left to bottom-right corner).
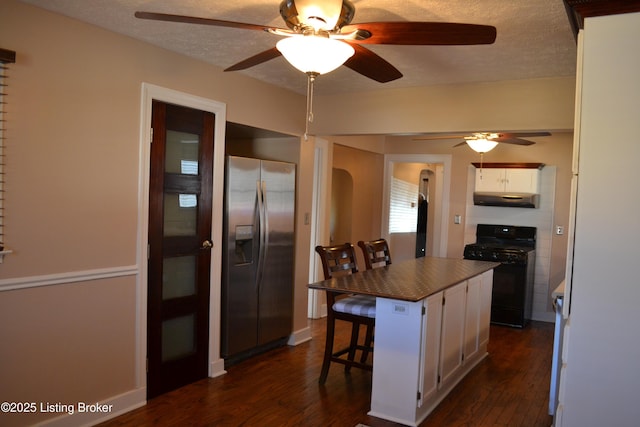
221;157;260;357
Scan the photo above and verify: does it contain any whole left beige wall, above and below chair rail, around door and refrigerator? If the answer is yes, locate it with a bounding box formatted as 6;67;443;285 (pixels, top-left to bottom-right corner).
0;0;312;425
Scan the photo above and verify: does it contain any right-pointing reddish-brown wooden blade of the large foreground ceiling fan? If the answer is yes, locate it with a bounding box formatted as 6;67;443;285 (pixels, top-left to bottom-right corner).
342;22;496;45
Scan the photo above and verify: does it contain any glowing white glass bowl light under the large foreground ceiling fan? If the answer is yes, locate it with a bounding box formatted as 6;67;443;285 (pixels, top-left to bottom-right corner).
276;35;355;74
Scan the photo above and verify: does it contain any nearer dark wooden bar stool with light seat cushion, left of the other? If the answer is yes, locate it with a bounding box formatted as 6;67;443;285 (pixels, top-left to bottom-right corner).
316;243;376;384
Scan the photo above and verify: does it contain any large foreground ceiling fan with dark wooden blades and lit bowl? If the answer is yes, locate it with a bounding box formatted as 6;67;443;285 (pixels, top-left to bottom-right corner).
135;0;496;83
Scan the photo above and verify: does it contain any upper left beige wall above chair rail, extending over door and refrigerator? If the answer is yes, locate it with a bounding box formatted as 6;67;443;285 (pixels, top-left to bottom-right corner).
0;0;304;278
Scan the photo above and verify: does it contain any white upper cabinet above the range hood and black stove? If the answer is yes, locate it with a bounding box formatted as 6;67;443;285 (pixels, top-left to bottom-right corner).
476;167;540;194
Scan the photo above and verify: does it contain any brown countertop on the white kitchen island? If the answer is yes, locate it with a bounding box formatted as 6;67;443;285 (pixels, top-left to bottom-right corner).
309;257;500;302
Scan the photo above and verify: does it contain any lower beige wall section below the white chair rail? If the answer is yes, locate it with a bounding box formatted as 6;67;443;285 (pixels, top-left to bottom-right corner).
0;277;137;426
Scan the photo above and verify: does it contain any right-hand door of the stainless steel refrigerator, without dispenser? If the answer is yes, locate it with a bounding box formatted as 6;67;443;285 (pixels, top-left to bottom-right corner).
258;160;296;345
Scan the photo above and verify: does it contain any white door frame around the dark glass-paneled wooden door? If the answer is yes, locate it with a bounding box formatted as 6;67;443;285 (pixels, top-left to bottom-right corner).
136;82;227;389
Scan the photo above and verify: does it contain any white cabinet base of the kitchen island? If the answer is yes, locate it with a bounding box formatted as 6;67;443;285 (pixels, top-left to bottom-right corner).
369;271;493;426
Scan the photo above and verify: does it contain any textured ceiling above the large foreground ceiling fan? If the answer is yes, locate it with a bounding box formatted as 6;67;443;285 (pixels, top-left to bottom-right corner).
18;0;576;94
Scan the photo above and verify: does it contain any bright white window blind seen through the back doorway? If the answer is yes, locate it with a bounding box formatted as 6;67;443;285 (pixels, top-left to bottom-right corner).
389;178;418;234
